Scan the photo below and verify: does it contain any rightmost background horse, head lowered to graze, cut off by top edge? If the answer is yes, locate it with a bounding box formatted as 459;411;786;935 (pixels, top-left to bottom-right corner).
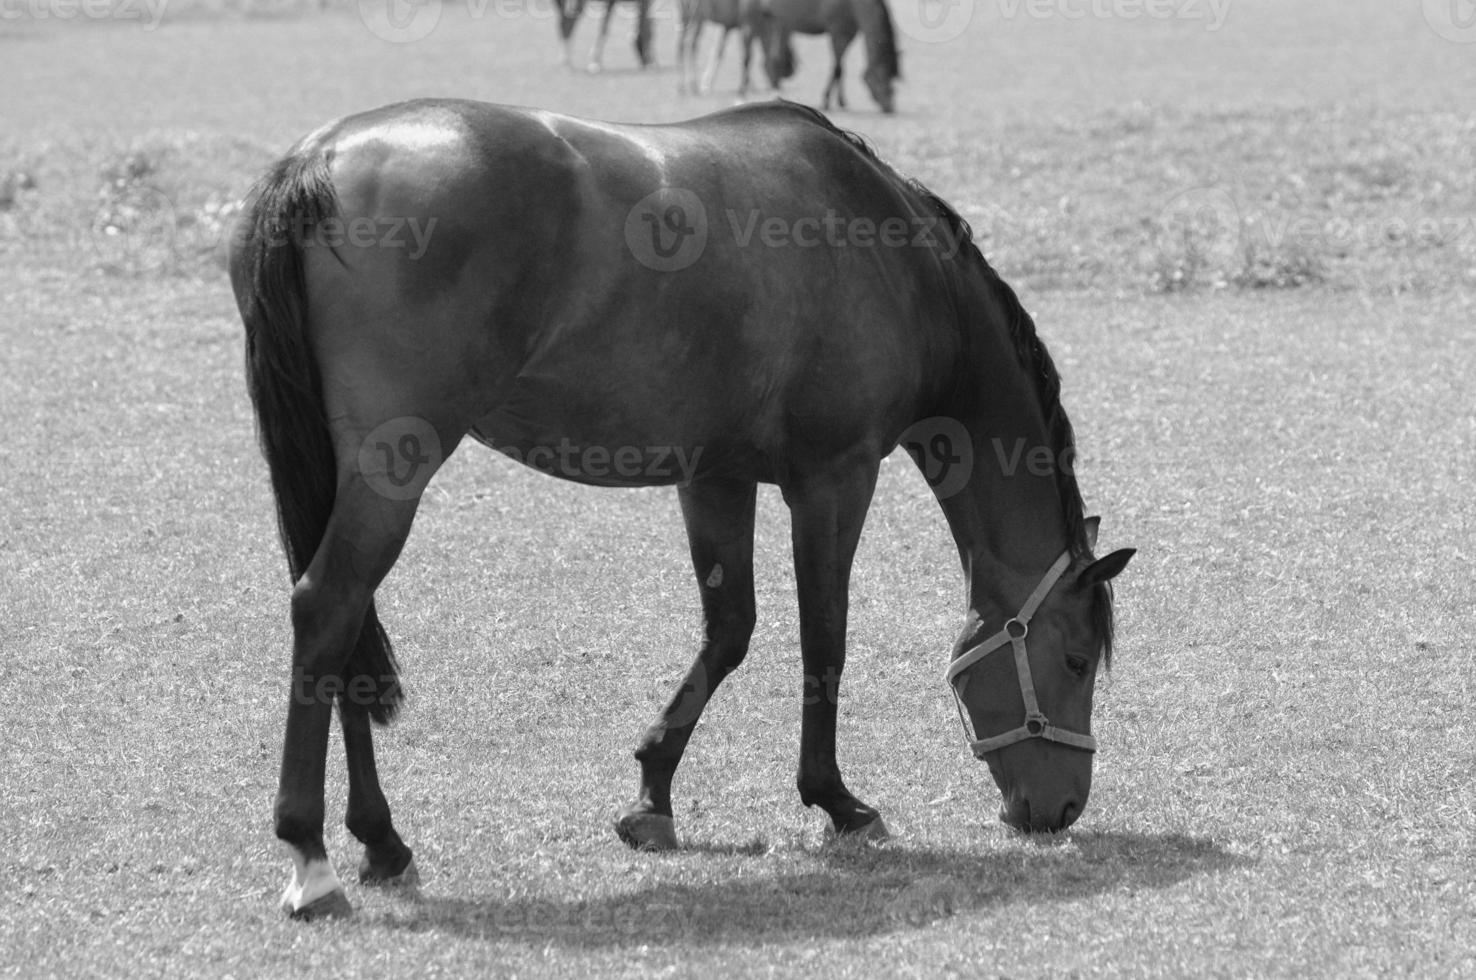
759;0;902;112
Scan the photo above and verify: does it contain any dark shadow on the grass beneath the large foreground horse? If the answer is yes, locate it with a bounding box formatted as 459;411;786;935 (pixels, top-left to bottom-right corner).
381;832;1252;948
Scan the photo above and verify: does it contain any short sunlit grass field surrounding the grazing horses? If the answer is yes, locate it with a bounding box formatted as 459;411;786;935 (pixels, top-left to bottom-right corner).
0;0;1476;977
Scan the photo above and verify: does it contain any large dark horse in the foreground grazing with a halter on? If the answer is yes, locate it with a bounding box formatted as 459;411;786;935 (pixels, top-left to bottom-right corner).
230;100;1132;917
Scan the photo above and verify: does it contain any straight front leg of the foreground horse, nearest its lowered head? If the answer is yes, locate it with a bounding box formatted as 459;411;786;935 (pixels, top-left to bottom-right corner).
782;459;889;840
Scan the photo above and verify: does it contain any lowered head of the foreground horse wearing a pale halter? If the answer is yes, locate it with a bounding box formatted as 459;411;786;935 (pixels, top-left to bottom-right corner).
948;518;1134;831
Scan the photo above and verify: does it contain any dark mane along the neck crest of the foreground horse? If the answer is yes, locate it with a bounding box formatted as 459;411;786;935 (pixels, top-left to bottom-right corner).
810;109;1113;664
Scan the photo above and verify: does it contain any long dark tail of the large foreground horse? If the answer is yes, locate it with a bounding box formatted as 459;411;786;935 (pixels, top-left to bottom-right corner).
230;148;403;725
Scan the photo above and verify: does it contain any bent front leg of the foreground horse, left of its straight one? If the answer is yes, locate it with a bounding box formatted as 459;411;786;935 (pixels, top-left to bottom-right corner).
615;481;757;850
